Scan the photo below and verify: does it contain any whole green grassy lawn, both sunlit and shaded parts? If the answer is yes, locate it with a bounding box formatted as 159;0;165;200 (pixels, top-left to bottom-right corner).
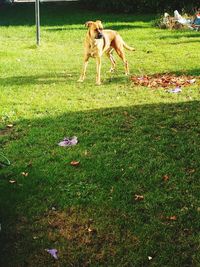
0;4;200;267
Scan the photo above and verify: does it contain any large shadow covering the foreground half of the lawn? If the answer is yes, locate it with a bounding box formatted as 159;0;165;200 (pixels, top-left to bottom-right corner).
0;101;200;267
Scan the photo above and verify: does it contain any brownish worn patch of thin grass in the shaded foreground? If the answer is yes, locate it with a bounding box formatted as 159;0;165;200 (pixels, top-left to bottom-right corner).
10;208;139;267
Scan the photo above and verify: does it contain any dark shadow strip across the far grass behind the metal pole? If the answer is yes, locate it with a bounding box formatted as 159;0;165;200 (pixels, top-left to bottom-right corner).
0;2;154;26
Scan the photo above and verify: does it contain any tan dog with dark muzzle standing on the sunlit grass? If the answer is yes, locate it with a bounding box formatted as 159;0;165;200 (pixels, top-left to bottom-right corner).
78;20;135;85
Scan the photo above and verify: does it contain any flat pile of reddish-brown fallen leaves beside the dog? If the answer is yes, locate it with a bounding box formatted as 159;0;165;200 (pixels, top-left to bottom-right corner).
131;73;197;88
